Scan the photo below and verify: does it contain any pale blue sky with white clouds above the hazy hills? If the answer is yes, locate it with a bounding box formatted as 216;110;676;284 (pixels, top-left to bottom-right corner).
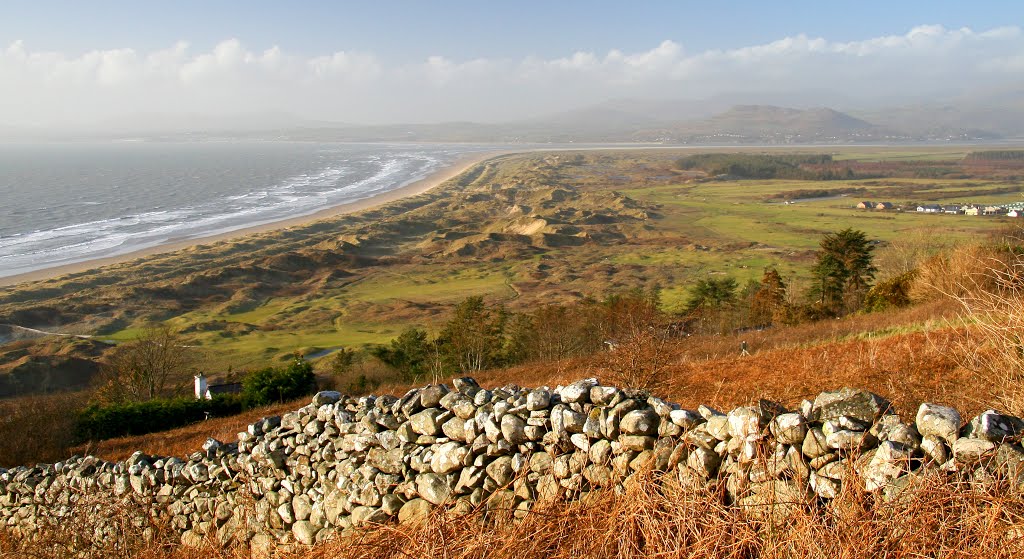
0;0;1024;126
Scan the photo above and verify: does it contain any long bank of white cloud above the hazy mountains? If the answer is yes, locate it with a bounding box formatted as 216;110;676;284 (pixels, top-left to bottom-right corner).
0;26;1024;124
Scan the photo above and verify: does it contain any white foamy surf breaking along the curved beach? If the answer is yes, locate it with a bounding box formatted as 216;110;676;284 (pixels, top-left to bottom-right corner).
0;141;477;276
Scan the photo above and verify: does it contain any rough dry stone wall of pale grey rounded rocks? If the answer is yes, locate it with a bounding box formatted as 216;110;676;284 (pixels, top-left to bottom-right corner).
0;378;1024;546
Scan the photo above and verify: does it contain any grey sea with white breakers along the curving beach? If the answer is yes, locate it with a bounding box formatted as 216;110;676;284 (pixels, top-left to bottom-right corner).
0;141;493;277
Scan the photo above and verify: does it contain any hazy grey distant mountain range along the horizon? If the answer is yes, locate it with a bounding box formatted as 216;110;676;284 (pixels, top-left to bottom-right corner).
6;84;1024;145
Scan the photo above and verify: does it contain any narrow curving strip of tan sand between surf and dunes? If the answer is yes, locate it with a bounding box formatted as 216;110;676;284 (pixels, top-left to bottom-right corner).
0;149;503;288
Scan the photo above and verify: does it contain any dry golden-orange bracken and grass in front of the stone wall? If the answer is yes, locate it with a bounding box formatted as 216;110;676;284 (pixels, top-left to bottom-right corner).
0;472;1024;559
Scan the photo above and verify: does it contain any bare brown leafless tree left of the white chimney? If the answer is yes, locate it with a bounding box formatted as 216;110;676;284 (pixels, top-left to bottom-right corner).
96;326;195;401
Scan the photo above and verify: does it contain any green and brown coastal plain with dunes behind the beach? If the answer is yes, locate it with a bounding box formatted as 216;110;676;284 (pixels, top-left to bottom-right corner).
0;147;1024;377
